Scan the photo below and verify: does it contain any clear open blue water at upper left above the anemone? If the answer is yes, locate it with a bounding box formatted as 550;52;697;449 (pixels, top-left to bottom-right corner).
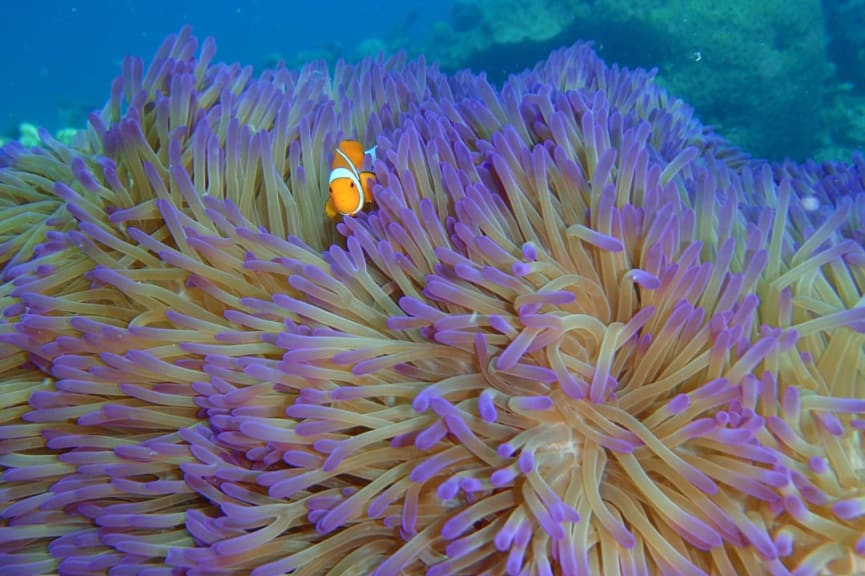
0;0;450;137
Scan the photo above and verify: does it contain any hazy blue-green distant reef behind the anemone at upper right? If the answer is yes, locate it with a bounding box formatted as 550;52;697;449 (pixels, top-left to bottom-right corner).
427;0;832;160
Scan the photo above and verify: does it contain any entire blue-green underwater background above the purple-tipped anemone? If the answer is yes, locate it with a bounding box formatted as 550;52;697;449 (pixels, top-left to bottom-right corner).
0;0;865;160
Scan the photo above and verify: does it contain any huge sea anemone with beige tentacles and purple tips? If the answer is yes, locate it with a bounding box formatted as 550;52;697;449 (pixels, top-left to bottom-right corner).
0;30;865;576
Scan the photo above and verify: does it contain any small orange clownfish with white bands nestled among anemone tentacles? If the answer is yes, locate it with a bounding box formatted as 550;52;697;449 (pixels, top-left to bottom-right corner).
324;140;376;219
